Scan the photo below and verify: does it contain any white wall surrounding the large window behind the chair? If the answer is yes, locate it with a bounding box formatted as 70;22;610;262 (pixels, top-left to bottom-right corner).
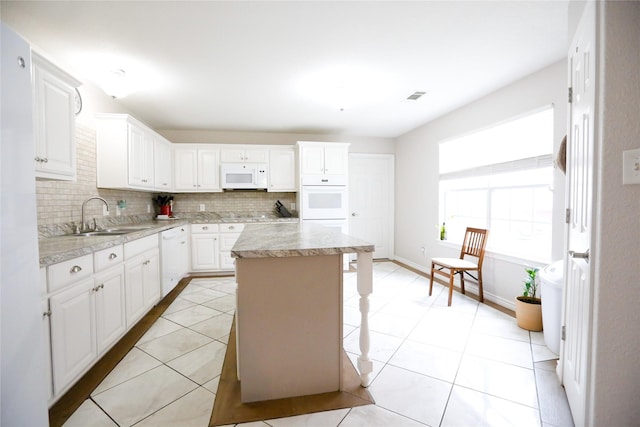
395;60;567;308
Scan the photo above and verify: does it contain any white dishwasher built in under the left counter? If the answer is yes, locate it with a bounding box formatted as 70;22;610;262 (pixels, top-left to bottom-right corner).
160;226;189;297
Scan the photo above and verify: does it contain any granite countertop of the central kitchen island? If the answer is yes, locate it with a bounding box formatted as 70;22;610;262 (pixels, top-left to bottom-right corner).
231;223;375;258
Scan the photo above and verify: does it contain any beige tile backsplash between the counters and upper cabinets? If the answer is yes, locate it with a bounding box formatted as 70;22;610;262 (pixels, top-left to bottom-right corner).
36;123;296;231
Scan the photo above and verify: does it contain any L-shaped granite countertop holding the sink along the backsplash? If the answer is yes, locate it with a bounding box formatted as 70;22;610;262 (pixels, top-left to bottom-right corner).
38;212;298;267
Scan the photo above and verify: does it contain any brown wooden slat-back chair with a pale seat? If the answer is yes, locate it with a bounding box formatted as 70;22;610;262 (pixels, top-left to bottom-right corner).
429;227;489;306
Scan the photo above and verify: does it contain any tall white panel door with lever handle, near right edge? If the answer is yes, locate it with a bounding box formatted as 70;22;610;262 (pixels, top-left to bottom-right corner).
561;3;596;425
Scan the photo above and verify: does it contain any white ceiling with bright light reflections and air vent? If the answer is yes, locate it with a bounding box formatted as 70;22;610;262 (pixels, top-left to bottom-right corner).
0;0;568;138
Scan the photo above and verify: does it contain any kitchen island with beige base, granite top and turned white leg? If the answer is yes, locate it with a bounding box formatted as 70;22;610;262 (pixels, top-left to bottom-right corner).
231;223;374;402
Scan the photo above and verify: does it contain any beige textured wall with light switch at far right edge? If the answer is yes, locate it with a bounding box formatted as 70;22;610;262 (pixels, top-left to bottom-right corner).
587;1;640;426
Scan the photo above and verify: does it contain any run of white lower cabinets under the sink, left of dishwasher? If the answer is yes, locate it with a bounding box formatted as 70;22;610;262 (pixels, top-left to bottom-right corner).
41;234;160;403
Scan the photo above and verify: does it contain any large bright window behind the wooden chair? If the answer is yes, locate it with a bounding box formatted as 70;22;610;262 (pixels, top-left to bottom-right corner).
439;108;553;261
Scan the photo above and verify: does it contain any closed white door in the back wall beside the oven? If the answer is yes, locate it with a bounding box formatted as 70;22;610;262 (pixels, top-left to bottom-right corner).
349;154;394;259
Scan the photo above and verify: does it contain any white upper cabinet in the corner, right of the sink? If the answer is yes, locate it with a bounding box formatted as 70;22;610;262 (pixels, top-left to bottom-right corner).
96;114;173;191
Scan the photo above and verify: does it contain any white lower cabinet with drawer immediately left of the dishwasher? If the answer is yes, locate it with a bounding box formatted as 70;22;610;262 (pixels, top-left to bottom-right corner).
124;235;161;328
